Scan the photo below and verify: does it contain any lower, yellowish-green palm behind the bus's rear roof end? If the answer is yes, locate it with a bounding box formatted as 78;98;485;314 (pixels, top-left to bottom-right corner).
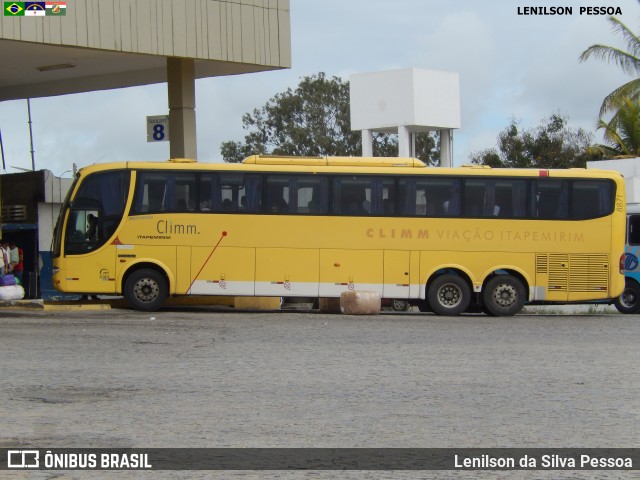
589;98;640;158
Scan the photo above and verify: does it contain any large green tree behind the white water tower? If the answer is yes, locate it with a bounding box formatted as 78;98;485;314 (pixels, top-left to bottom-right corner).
220;72;439;164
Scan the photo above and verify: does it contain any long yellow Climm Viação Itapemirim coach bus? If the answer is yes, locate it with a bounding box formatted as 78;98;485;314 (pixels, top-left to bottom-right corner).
53;156;625;315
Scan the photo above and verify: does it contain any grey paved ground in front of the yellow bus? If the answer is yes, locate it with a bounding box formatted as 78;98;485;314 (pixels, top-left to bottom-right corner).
0;309;640;479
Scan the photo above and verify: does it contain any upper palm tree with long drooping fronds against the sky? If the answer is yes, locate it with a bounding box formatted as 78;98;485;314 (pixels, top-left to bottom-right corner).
580;7;640;117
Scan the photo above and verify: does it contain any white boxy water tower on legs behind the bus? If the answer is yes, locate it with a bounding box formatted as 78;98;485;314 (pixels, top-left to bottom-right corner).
350;68;460;167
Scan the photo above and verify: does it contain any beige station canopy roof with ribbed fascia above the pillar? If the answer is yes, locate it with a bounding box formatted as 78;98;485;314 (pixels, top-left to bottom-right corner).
0;0;291;101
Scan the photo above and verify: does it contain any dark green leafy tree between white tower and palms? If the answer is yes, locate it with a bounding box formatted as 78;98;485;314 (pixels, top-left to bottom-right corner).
469;114;595;168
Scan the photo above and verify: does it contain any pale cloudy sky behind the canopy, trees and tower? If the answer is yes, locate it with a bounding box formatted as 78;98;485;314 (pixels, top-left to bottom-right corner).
0;0;640;176
